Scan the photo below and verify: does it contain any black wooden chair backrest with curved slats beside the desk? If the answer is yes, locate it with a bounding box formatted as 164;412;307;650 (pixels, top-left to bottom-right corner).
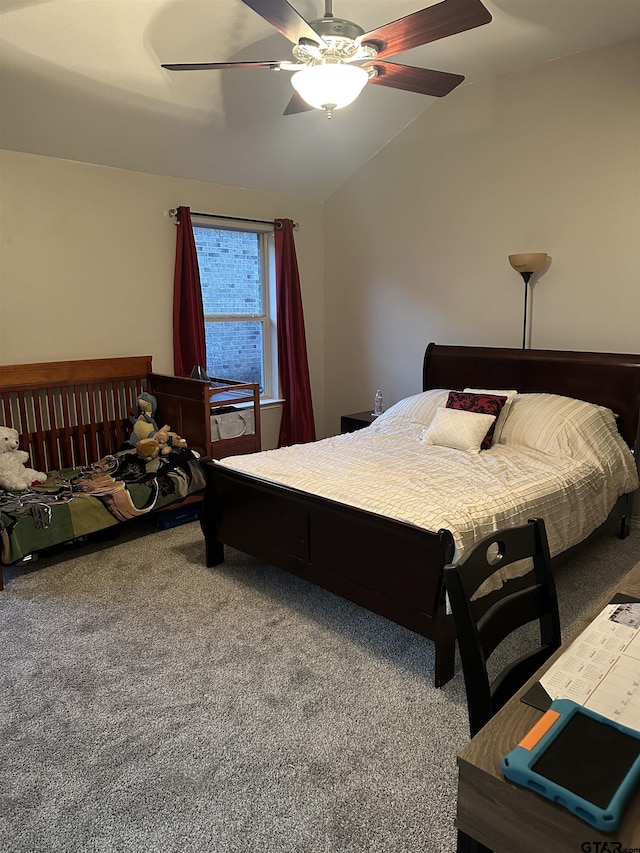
444;519;561;737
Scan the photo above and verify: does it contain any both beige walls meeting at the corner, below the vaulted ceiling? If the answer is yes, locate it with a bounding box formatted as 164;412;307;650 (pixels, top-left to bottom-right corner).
0;40;640;446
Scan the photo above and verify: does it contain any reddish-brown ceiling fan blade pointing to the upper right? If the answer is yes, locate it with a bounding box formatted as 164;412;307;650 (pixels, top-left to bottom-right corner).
356;0;491;60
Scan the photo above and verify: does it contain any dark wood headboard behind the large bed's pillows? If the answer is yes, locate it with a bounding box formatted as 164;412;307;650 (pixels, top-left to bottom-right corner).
422;343;640;450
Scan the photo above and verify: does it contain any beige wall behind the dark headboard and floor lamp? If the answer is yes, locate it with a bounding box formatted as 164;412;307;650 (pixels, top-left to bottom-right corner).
325;40;640;436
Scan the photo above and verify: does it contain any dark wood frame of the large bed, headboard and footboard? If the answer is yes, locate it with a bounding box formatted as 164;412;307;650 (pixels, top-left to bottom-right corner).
201;343;640;686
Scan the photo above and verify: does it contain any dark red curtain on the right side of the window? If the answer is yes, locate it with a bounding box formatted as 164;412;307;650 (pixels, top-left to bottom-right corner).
275;219;316;447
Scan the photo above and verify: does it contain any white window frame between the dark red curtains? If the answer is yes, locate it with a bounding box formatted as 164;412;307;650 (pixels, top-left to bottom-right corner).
192;215;279;402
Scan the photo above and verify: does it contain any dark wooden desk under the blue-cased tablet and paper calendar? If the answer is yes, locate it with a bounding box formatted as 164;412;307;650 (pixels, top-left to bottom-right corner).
458;563;640;853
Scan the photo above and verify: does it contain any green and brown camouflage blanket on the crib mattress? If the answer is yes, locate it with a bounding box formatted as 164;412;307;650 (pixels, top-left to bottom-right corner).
0;449;204;565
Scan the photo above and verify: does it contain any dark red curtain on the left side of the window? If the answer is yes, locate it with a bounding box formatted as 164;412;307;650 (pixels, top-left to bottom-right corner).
173;207;207;376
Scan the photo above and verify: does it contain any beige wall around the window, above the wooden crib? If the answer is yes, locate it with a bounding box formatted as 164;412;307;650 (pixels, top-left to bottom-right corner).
0;151;324;446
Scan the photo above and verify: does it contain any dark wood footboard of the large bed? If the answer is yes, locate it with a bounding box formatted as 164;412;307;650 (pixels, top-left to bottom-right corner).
201;462;455;686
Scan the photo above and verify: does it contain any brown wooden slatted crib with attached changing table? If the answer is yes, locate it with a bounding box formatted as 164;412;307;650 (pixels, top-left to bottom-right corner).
0;356;260;589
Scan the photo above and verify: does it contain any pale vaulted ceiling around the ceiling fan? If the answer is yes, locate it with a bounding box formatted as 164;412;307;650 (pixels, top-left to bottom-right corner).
0;0;640;201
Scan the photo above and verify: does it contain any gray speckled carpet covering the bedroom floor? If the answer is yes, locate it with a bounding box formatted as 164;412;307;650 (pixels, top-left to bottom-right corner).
0;523;640;853
